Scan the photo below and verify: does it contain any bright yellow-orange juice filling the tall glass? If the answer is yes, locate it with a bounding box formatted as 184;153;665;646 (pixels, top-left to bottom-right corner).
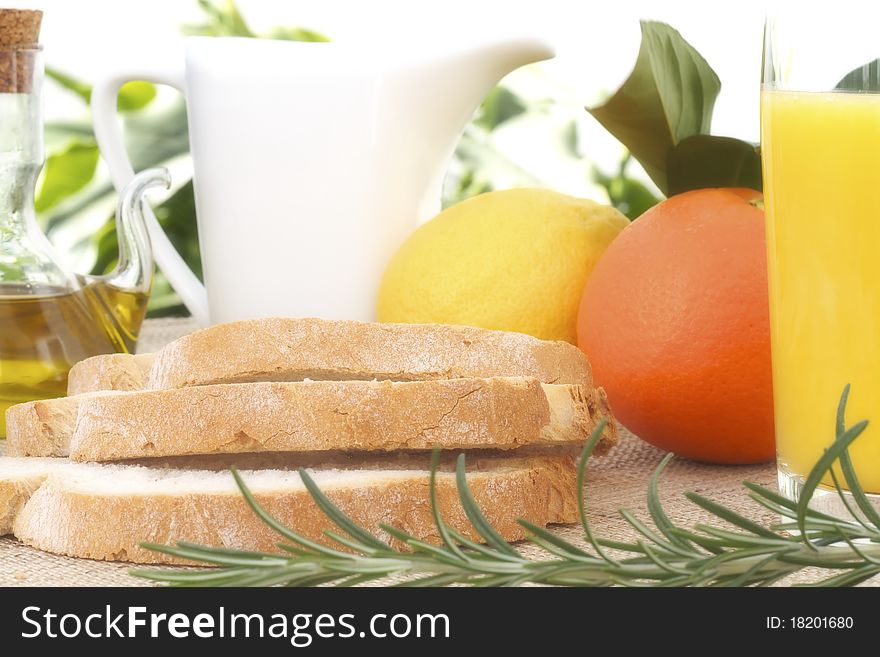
761;91;880;493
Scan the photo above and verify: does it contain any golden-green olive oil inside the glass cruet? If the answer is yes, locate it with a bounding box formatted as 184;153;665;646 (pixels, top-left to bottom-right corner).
0;281;148;438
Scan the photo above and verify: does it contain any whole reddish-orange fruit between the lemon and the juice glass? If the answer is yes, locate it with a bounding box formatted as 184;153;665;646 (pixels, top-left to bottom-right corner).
578;189;774;463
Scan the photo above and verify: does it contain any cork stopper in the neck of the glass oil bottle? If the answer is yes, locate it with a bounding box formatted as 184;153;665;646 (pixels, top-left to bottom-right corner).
0;9;43;93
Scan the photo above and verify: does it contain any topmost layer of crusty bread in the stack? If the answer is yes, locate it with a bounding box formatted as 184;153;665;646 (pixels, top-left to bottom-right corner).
68;318;592;395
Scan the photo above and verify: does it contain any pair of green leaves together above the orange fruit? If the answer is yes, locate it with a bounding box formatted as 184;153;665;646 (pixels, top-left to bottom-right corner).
587;22;761;195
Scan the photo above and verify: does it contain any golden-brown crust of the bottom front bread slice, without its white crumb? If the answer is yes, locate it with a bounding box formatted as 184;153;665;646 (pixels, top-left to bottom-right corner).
14;456;577;564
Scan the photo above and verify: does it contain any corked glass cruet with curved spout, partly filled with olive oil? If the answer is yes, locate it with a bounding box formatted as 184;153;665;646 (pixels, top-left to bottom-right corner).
0;9;155;438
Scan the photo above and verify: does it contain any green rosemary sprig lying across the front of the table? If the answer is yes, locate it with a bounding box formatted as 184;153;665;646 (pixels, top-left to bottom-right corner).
131;386;880;586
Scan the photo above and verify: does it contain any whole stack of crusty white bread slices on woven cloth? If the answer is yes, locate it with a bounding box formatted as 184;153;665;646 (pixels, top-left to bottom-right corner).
0;319;616;563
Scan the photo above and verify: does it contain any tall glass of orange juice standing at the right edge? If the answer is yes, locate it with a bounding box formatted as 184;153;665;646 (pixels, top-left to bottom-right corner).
761;7;880;513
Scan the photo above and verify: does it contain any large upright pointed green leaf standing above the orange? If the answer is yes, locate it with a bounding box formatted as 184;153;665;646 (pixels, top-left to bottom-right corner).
587;21;721;193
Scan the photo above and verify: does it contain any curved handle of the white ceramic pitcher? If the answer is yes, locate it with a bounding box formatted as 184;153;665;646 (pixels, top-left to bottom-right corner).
92;67;209;326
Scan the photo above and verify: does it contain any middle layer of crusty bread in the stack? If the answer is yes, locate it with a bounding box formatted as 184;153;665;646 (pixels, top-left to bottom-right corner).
7;377;616;461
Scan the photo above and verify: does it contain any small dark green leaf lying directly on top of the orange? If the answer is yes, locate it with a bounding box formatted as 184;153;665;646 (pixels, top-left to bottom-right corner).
666;135;763;196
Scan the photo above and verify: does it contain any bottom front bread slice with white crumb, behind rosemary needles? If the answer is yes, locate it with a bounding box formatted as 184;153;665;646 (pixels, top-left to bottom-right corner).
13;450;577;563
